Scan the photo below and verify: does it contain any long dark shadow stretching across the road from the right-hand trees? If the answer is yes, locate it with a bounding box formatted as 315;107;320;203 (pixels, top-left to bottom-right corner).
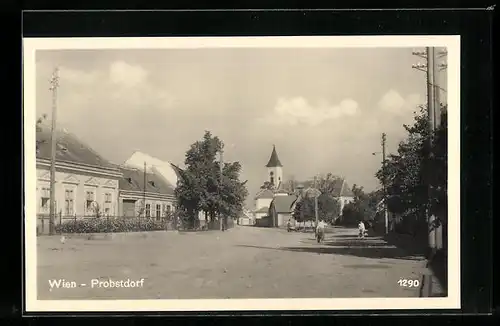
237;244;423;260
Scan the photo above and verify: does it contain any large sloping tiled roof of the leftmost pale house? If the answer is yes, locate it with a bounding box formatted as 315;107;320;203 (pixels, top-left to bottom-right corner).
36;125;115;168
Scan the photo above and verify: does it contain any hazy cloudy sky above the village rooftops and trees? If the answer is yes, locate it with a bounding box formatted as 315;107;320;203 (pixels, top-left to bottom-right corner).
36;48;446;208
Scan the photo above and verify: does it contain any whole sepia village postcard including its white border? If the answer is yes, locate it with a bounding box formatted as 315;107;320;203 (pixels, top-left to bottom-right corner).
23;36;460;311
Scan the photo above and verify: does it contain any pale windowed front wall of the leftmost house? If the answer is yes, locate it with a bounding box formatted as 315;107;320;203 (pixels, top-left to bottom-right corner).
36;167;119;217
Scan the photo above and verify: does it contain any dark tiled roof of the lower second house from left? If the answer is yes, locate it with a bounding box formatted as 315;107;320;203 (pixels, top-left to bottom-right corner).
119;167;174;195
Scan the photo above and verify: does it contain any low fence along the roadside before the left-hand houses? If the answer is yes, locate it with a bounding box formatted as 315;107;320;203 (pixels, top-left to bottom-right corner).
36;213;235;235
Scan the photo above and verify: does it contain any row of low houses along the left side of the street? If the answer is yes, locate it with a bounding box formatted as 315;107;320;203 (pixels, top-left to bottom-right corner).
36;125;180;219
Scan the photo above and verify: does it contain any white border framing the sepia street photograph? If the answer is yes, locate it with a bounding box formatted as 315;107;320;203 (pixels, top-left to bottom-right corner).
23;35;460;312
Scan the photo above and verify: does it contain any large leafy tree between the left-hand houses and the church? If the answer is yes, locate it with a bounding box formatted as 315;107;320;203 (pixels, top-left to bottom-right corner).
175;131;248;227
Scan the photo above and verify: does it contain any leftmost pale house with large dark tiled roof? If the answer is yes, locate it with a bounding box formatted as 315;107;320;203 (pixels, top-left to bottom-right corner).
36;124;122;228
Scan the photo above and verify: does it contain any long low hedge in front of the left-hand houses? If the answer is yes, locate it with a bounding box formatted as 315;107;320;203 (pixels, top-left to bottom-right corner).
56;218;169;233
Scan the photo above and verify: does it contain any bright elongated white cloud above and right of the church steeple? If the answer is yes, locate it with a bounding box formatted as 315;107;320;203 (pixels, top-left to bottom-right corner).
264;97;358;126
